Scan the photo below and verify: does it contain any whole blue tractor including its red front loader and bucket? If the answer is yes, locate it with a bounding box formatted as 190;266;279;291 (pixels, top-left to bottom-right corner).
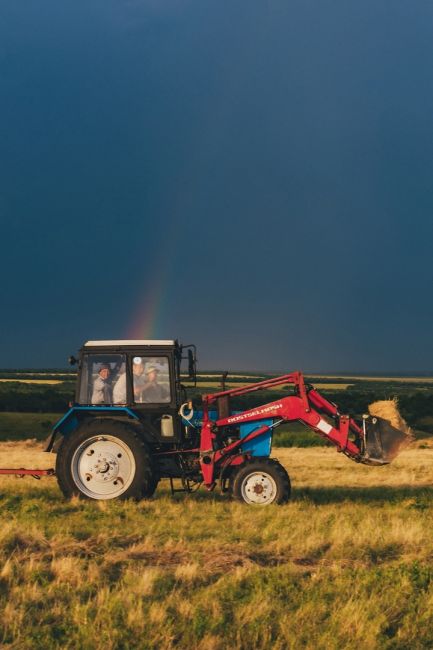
49;340;411;505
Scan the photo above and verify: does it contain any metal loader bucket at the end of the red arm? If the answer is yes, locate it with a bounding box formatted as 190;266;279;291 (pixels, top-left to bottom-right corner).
362;415;412;465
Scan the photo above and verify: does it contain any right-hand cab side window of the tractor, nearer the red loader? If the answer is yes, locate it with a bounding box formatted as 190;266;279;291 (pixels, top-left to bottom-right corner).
132;356;171;404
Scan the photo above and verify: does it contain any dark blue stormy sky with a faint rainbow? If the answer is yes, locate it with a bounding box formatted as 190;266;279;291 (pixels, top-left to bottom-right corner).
0;0;433;371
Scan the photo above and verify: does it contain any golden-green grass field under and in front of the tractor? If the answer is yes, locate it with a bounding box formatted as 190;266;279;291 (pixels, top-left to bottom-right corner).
0;442;433;650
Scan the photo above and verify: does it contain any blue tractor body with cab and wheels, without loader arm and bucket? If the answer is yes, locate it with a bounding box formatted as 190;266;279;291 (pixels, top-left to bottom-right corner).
46;340;290;505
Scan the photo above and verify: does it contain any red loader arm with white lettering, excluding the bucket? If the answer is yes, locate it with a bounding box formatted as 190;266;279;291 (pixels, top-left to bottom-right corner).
200;372;363;487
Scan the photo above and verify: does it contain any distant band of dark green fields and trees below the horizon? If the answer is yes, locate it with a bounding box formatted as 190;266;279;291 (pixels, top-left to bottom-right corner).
0;369;433;438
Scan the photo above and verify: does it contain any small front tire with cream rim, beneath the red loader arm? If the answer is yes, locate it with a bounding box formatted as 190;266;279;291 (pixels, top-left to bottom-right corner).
231;458;291;506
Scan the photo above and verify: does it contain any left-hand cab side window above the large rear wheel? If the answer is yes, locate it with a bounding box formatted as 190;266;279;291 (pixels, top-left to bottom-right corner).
80;354;126;405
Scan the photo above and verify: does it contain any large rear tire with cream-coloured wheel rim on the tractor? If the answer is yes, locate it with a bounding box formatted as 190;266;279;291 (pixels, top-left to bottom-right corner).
56;418;158;500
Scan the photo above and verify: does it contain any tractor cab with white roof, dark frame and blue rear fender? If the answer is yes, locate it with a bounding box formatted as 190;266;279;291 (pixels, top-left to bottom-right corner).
42;340;196;451
